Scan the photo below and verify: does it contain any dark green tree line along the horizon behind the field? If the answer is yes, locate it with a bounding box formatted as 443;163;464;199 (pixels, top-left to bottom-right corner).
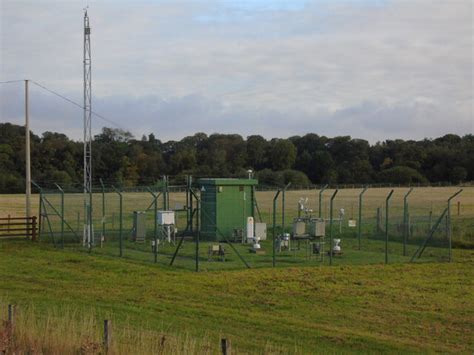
0;123;474;193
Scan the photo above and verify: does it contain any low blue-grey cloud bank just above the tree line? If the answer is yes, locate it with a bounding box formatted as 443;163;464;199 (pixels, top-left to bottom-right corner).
0;81;473;143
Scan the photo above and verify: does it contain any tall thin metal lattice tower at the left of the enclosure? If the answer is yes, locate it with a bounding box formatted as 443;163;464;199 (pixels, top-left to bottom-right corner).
83;10;94;249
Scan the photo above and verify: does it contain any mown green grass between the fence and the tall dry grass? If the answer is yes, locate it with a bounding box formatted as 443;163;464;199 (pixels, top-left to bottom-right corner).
0;241;474;353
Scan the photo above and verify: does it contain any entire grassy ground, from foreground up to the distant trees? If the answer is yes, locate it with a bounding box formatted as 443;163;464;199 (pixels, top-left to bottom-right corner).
0;187;474;354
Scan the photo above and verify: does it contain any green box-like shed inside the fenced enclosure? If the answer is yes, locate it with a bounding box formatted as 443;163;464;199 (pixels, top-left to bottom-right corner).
198;179;258;240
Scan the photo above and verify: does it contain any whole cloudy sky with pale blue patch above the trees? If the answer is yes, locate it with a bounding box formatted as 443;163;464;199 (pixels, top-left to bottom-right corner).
0;0;474;143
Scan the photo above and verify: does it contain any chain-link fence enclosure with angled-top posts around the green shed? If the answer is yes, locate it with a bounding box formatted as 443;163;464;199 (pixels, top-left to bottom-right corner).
31;177;474;270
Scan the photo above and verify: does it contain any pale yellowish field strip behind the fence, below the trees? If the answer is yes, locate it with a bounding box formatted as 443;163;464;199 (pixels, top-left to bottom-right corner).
0;187;474;222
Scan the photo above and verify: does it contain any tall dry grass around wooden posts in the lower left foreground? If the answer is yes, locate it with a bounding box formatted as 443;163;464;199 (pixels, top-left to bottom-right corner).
0;302;219;355
